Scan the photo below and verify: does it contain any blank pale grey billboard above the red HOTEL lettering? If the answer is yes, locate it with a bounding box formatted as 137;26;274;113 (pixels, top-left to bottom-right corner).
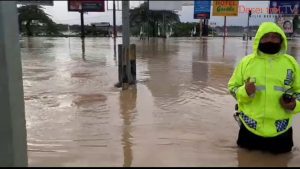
149;0;182;11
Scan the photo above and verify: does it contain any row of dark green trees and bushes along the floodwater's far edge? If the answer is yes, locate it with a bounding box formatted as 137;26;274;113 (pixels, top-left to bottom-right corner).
18;2;300;37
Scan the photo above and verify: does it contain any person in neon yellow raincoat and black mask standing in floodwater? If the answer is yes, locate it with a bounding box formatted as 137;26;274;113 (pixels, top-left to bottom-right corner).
228;22;300;154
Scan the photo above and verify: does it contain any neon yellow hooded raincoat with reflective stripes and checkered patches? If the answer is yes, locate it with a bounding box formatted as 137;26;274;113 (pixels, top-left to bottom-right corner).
228;22;300;137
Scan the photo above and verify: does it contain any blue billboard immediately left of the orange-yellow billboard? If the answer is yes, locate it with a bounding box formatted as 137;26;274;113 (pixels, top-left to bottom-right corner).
194;0;211;19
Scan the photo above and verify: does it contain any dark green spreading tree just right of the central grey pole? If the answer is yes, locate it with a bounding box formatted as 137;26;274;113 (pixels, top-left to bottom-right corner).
130;2;180;36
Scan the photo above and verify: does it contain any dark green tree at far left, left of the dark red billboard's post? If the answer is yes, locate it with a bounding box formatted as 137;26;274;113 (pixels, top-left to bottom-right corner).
18;5;59;36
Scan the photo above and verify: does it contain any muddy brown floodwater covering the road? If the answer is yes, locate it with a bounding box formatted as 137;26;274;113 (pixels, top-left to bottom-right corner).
21;38;300;166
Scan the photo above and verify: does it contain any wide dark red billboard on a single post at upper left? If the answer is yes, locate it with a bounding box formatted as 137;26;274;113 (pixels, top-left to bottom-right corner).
68;0;105;12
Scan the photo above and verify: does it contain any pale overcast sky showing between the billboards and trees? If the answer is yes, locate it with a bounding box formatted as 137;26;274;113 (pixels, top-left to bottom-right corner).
44;1;274;26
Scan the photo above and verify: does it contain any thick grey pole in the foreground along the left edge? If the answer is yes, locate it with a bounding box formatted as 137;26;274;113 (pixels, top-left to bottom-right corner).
0;1;28;167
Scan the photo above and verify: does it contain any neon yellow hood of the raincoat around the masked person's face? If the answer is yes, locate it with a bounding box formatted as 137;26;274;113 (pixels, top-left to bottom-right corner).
253;22;287;56
